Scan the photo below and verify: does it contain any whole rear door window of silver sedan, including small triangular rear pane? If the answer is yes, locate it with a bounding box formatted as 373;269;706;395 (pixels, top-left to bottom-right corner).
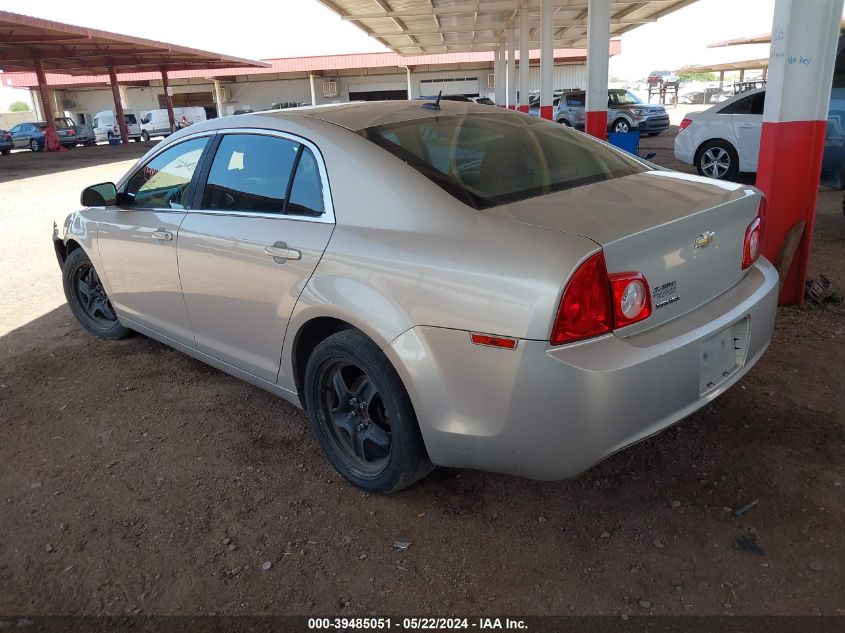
203;134;325;217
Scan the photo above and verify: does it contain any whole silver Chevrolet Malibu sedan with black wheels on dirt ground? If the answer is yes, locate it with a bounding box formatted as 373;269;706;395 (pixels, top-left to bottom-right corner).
54;101;778;492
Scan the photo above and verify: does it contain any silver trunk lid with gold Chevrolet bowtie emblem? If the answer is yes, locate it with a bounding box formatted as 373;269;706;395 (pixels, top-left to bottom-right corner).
491;171;760;335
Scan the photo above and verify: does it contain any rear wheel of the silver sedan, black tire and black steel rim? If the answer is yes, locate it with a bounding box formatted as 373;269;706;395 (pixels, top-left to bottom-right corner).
304;330;434;494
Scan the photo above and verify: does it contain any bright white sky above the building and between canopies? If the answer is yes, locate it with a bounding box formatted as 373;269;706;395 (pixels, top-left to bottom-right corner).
0;0;774;109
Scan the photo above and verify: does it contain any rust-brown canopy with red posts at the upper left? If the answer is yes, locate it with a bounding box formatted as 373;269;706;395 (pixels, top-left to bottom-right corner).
0;11;267;144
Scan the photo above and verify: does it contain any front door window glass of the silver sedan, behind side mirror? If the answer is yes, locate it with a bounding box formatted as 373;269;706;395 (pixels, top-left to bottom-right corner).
120;137;208;209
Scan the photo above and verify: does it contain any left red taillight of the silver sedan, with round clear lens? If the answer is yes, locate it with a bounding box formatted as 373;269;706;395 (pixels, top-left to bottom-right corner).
551;251;651;345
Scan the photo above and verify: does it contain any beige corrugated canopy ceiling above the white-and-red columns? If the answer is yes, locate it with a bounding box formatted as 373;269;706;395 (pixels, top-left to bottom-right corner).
318;0;696;55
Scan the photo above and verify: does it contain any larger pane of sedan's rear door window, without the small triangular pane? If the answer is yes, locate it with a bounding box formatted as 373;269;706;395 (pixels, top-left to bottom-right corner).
202;134;301;214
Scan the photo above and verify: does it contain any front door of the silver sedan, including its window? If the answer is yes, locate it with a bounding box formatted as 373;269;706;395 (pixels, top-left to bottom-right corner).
98;134;212;346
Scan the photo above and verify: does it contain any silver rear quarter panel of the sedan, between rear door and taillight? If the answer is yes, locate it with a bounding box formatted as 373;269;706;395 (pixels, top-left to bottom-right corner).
280;115;598;386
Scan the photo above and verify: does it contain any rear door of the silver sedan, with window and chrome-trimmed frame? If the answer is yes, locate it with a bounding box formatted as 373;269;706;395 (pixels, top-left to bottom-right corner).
177;130;334;382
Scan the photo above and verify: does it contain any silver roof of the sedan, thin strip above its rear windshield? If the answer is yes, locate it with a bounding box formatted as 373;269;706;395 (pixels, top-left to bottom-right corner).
239;100;496;132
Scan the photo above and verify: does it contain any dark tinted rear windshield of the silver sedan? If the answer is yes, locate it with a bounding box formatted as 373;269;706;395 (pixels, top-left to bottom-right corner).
362;112;649;209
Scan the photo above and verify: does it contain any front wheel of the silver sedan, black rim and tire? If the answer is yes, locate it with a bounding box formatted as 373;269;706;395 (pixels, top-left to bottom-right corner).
62;248;132;340
